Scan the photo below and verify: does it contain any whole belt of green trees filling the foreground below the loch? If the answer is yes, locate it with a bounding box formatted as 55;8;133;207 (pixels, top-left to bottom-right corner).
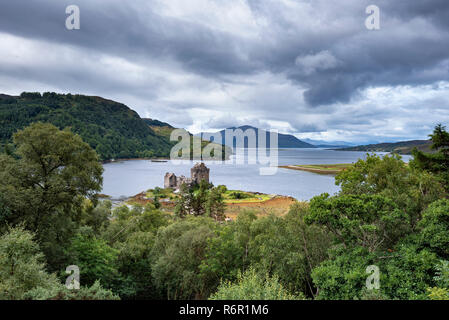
0;123;449;299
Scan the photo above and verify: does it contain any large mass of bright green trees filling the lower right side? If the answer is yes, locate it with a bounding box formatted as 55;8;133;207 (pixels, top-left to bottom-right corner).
305;145;448;299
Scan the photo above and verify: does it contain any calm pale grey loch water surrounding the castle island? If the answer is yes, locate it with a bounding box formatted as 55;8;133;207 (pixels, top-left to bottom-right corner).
102;149;410;200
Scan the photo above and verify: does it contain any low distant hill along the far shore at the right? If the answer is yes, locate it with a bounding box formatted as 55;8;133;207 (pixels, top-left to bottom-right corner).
338;140;433;154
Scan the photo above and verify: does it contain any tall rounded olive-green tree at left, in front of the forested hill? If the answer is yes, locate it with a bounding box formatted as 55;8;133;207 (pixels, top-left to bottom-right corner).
0;123;103;267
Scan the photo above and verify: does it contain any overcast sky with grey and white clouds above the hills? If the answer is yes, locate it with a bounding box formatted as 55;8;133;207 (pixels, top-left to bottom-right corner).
0;0;449;144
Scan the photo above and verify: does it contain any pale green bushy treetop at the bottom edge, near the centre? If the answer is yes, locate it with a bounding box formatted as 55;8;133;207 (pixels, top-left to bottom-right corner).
209;269;304;300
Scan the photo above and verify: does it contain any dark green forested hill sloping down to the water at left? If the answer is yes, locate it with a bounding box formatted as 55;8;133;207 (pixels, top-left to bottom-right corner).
0;93;173;160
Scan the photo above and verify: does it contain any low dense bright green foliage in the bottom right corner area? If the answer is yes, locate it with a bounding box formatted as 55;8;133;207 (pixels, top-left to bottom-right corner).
312;244;437;300
